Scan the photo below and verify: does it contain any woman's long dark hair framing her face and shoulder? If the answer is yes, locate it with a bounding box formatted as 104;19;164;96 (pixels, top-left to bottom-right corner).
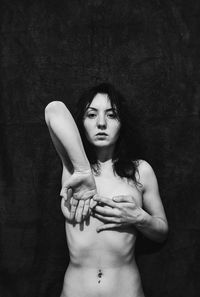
76;83;141;183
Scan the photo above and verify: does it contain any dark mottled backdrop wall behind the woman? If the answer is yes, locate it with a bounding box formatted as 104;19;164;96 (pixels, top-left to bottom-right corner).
0;0;200;297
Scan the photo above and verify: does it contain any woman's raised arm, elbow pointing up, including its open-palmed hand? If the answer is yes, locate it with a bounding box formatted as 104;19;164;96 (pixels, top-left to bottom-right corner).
45;101;96;222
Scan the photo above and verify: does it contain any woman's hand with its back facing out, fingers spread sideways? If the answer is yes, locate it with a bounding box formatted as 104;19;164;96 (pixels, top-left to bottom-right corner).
92;195;144;232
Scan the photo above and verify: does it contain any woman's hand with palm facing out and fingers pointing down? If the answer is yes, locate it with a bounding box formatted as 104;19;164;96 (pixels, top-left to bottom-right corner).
60;170;96;223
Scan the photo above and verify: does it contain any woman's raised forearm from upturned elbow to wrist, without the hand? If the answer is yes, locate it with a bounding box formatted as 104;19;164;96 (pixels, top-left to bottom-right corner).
45;101;90;171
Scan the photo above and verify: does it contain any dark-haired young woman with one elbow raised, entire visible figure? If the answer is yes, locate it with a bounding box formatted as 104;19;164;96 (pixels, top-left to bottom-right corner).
45;84;168;297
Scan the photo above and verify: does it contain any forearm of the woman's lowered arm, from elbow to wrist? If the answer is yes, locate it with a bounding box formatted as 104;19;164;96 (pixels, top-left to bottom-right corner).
135;211;168;242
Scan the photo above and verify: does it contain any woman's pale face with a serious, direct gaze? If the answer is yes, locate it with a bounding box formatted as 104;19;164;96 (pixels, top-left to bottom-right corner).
83;93;121;148
